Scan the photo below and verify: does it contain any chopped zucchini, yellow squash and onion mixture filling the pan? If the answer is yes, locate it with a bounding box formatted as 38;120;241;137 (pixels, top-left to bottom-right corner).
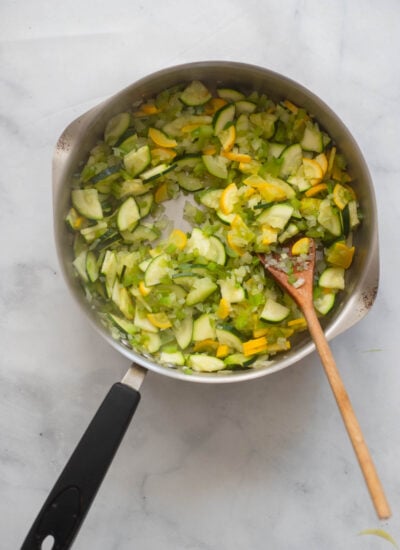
66;81;360;373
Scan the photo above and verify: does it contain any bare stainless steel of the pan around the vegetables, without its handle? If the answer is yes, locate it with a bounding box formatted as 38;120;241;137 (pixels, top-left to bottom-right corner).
53;61;379;383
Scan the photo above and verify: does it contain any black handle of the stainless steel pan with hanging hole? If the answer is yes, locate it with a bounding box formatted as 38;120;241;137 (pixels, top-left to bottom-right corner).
21;382;140;550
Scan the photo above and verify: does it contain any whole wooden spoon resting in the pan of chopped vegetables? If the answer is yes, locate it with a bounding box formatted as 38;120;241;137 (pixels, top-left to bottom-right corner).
259;239;391;519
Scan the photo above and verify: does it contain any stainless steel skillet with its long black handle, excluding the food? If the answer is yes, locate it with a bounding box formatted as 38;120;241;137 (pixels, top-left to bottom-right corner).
22;61;379;550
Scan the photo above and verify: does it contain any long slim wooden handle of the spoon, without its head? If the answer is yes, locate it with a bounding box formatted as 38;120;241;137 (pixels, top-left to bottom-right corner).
303;306;391;519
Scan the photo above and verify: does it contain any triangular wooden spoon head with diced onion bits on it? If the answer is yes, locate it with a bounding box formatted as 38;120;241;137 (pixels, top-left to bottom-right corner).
258;238;316;309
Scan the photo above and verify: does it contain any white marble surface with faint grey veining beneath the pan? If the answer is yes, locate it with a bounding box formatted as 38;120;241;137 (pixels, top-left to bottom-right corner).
0;0;400;550
